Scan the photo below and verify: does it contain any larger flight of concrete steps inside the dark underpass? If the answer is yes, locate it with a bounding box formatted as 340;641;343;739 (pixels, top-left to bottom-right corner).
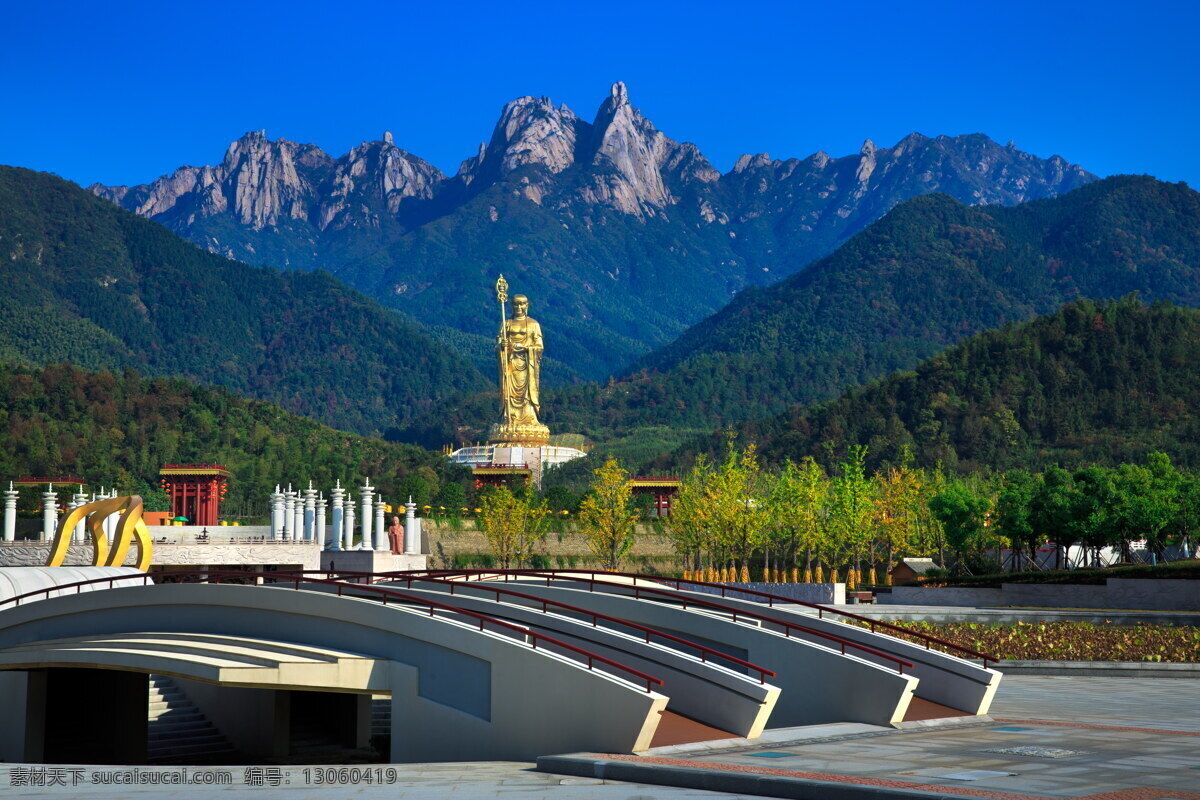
146;675;240;764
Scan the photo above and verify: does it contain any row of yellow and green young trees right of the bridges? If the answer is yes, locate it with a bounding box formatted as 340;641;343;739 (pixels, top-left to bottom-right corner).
667;445;1200;585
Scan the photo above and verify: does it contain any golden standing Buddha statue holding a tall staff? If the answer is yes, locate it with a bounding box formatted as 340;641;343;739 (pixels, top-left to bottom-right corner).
488;276;550;445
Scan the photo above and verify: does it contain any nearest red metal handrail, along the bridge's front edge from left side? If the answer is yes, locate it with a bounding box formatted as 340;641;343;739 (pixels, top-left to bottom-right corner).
0;570;664;692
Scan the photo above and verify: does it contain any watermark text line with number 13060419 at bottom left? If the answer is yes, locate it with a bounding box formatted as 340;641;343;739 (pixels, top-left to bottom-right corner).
7;766;400;788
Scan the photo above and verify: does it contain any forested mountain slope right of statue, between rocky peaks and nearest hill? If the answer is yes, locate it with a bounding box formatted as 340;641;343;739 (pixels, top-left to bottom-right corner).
396;176;1200;450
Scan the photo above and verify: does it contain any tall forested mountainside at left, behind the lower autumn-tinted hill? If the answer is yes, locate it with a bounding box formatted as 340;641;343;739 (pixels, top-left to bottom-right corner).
0;167;487;433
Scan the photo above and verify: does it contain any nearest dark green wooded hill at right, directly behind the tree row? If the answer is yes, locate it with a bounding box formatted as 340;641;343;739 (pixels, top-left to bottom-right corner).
679;299;1200;471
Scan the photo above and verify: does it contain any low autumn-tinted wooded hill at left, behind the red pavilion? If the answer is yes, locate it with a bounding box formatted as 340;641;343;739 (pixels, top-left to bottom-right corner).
0;365;466;515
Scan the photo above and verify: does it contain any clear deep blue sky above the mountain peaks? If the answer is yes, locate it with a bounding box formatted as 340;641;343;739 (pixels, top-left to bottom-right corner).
0;0;1200;186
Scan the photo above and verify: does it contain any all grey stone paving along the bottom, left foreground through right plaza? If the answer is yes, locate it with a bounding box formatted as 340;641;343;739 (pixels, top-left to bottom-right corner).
0;675;1200;800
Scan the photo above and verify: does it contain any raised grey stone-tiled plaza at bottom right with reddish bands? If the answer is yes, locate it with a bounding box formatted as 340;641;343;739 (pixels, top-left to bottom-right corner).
539;675;1200;800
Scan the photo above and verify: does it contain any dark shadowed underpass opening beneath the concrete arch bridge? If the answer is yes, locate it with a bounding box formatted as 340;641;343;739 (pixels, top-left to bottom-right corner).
0;667;374;765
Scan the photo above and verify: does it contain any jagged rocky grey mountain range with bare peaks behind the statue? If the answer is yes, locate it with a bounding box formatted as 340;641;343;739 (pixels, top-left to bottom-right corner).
90;83;1094;383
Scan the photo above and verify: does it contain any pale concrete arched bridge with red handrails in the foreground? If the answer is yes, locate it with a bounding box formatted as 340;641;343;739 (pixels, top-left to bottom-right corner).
0;571;1000;763
